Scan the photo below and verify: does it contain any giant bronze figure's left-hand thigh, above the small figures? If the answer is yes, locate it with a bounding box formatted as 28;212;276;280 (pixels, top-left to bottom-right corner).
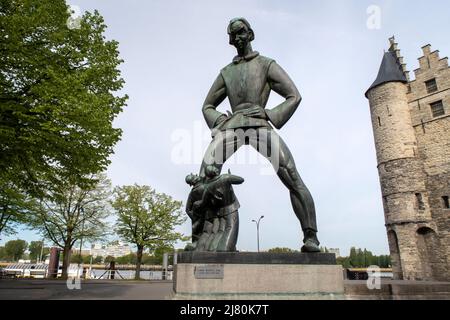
200;130;243;176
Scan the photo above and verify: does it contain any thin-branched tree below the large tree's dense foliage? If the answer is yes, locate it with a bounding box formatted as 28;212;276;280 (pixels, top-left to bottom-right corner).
30;174;111;278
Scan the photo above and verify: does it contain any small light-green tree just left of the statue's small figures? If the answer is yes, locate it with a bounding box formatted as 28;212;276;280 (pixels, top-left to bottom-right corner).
112;185;187;279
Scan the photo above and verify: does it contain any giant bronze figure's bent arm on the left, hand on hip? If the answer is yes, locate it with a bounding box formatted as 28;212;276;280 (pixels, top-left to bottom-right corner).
203;74;227;129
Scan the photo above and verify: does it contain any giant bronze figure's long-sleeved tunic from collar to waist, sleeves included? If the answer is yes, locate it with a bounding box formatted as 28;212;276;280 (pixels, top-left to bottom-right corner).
203;51;301;130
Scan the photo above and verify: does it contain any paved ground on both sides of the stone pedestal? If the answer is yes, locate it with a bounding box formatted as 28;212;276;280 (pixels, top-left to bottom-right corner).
0;279;450;300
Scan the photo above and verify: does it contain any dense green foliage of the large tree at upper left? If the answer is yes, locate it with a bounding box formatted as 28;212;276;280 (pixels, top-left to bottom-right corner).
0;0;127;194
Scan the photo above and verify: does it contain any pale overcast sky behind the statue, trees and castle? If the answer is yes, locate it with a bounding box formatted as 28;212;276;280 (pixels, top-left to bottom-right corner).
1;0;450;254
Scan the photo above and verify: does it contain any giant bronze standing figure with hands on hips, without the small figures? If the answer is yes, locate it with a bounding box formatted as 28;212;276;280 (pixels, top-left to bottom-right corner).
200;18;320;252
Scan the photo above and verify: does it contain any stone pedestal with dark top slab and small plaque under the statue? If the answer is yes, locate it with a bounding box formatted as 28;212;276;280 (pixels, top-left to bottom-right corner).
173;252;344;300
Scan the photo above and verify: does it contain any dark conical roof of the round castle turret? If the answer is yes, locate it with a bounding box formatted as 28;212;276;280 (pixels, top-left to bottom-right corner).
366;38;408;97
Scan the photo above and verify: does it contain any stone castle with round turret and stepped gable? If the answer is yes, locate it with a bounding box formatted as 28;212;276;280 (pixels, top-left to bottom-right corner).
366;38;450;280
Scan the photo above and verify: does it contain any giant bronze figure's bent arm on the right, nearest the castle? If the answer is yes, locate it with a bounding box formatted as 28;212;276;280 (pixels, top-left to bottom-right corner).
266;62;302;129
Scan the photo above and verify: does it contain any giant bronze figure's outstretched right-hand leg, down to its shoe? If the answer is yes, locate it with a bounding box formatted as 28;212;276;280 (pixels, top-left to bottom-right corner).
250;129;320;252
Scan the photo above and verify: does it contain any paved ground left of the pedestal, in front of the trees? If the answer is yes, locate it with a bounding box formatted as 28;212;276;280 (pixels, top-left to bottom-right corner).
0;279;173;300
